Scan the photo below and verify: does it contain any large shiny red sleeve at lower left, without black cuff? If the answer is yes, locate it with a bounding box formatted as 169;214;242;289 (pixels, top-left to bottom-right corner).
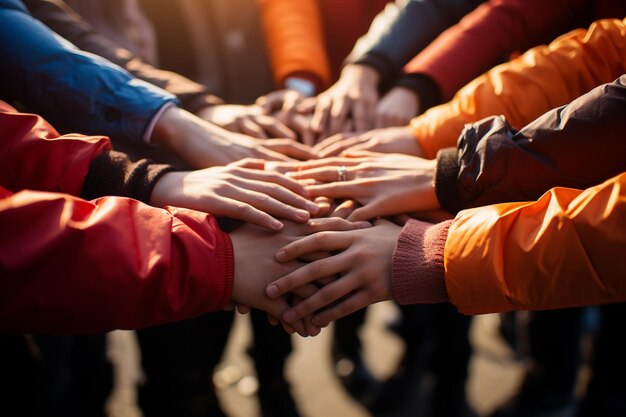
0;187;234;334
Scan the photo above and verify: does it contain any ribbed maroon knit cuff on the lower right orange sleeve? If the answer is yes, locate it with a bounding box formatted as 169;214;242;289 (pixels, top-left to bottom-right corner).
391;220;452;304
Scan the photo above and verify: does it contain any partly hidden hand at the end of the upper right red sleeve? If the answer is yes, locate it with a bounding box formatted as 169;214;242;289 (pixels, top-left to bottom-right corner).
376;87;419;128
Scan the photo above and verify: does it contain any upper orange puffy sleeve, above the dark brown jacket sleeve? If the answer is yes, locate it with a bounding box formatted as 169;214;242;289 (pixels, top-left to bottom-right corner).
411;19;626;158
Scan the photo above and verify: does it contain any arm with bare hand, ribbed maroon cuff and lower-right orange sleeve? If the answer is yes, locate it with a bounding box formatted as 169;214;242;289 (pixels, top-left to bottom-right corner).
267;174;626;327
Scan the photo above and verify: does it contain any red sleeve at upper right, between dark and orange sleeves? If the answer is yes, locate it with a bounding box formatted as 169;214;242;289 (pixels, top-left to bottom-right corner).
406;0;588;101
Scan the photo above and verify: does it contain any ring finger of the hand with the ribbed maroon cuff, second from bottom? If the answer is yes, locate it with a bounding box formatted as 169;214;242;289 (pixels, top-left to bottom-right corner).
282;275;358;323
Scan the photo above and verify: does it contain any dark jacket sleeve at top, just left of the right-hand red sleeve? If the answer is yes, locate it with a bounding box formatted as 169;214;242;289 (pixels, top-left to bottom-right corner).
351;0;480;83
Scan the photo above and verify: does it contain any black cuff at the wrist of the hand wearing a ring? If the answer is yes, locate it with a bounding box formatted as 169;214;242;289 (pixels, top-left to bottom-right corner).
435;148;462;214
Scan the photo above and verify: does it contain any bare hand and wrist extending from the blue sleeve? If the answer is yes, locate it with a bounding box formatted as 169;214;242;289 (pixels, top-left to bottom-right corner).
151;106;316;168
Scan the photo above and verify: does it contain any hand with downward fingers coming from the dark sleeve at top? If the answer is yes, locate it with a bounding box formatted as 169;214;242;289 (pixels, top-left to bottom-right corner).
298;64;380;139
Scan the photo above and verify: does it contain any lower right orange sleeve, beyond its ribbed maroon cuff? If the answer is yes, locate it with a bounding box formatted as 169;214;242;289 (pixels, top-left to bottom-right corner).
444;173;626;314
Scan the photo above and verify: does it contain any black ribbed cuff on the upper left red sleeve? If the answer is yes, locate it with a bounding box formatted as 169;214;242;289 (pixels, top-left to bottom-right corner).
81;151;174;204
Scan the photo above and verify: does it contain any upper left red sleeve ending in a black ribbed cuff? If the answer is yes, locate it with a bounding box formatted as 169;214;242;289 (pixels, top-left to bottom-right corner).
0;101;111;195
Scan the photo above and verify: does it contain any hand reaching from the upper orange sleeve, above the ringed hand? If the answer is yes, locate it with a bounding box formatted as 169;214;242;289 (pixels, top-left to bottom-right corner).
313;126;422;158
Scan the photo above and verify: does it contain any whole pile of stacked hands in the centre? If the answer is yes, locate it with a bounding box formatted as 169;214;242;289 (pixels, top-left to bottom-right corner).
150;64;439;336
